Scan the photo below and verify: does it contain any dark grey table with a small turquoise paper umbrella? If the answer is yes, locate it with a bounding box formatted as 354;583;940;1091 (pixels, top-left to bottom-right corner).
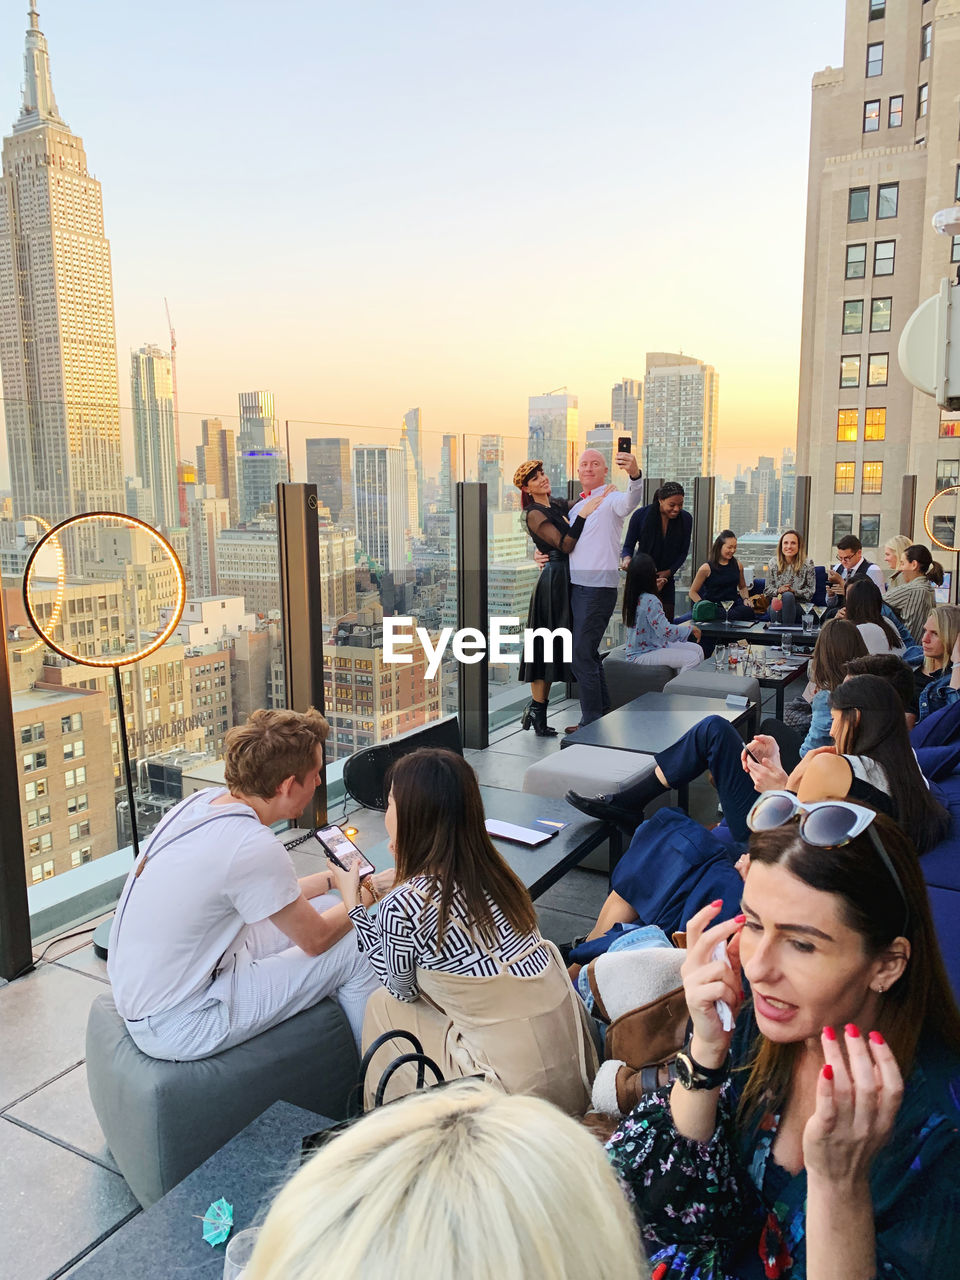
70;1102;334;1280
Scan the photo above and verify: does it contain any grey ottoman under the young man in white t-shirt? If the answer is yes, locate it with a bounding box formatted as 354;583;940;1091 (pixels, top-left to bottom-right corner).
87;996;360;1212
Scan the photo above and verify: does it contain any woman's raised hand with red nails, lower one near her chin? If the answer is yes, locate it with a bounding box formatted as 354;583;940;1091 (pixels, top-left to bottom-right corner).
803;1024;904;1188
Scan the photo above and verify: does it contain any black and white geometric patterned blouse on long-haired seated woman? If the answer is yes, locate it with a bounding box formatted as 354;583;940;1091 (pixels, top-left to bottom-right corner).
349;876;550;1002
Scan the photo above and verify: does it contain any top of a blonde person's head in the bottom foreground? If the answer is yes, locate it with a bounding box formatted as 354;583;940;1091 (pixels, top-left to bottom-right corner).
243;1080;649;1280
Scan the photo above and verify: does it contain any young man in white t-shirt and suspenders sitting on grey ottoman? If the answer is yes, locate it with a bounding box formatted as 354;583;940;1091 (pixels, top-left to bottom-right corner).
108;710;393;1061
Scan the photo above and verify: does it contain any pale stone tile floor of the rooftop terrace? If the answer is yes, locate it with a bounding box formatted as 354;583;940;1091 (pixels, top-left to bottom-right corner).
0;703;717;1280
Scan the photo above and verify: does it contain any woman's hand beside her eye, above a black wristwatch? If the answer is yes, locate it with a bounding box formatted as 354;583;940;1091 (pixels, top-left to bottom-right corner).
680;901;744;1066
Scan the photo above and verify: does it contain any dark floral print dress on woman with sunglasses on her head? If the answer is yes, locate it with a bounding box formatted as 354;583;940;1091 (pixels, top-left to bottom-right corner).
607;1006;960;1280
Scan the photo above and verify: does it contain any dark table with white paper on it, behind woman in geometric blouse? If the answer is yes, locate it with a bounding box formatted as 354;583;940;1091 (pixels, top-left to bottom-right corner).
365;783;611;899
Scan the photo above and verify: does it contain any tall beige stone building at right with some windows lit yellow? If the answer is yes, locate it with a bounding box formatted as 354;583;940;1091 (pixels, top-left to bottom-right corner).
796;0;960;562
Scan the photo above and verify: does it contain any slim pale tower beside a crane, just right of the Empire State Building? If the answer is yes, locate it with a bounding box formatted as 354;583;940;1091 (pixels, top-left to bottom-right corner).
131;346;180;530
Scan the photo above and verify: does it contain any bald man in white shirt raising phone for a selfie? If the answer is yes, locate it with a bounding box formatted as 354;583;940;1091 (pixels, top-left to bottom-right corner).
567;449;644;732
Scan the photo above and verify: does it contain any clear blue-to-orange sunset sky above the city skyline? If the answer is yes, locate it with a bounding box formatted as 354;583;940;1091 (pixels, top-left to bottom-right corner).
0;0;845;480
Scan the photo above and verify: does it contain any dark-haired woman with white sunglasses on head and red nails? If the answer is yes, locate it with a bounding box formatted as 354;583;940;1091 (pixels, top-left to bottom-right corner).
608;808;960;1280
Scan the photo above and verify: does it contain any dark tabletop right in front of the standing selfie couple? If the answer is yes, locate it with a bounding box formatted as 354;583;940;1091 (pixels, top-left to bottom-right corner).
563;692;753;755
